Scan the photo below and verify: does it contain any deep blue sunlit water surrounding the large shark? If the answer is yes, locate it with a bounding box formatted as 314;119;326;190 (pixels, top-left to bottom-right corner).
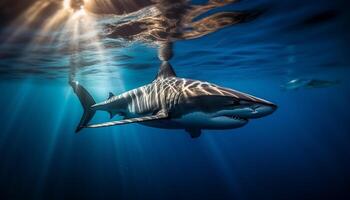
0;0;350;200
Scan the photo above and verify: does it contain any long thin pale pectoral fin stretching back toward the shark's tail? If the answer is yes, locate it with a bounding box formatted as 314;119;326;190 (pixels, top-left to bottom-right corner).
86;111;168;128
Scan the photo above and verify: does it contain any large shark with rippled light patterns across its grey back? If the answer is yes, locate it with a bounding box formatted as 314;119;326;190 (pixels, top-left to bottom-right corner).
70;62;277;138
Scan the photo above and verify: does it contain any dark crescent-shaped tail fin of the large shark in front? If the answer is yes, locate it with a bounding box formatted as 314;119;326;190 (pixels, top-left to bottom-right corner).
69;81;96;133
